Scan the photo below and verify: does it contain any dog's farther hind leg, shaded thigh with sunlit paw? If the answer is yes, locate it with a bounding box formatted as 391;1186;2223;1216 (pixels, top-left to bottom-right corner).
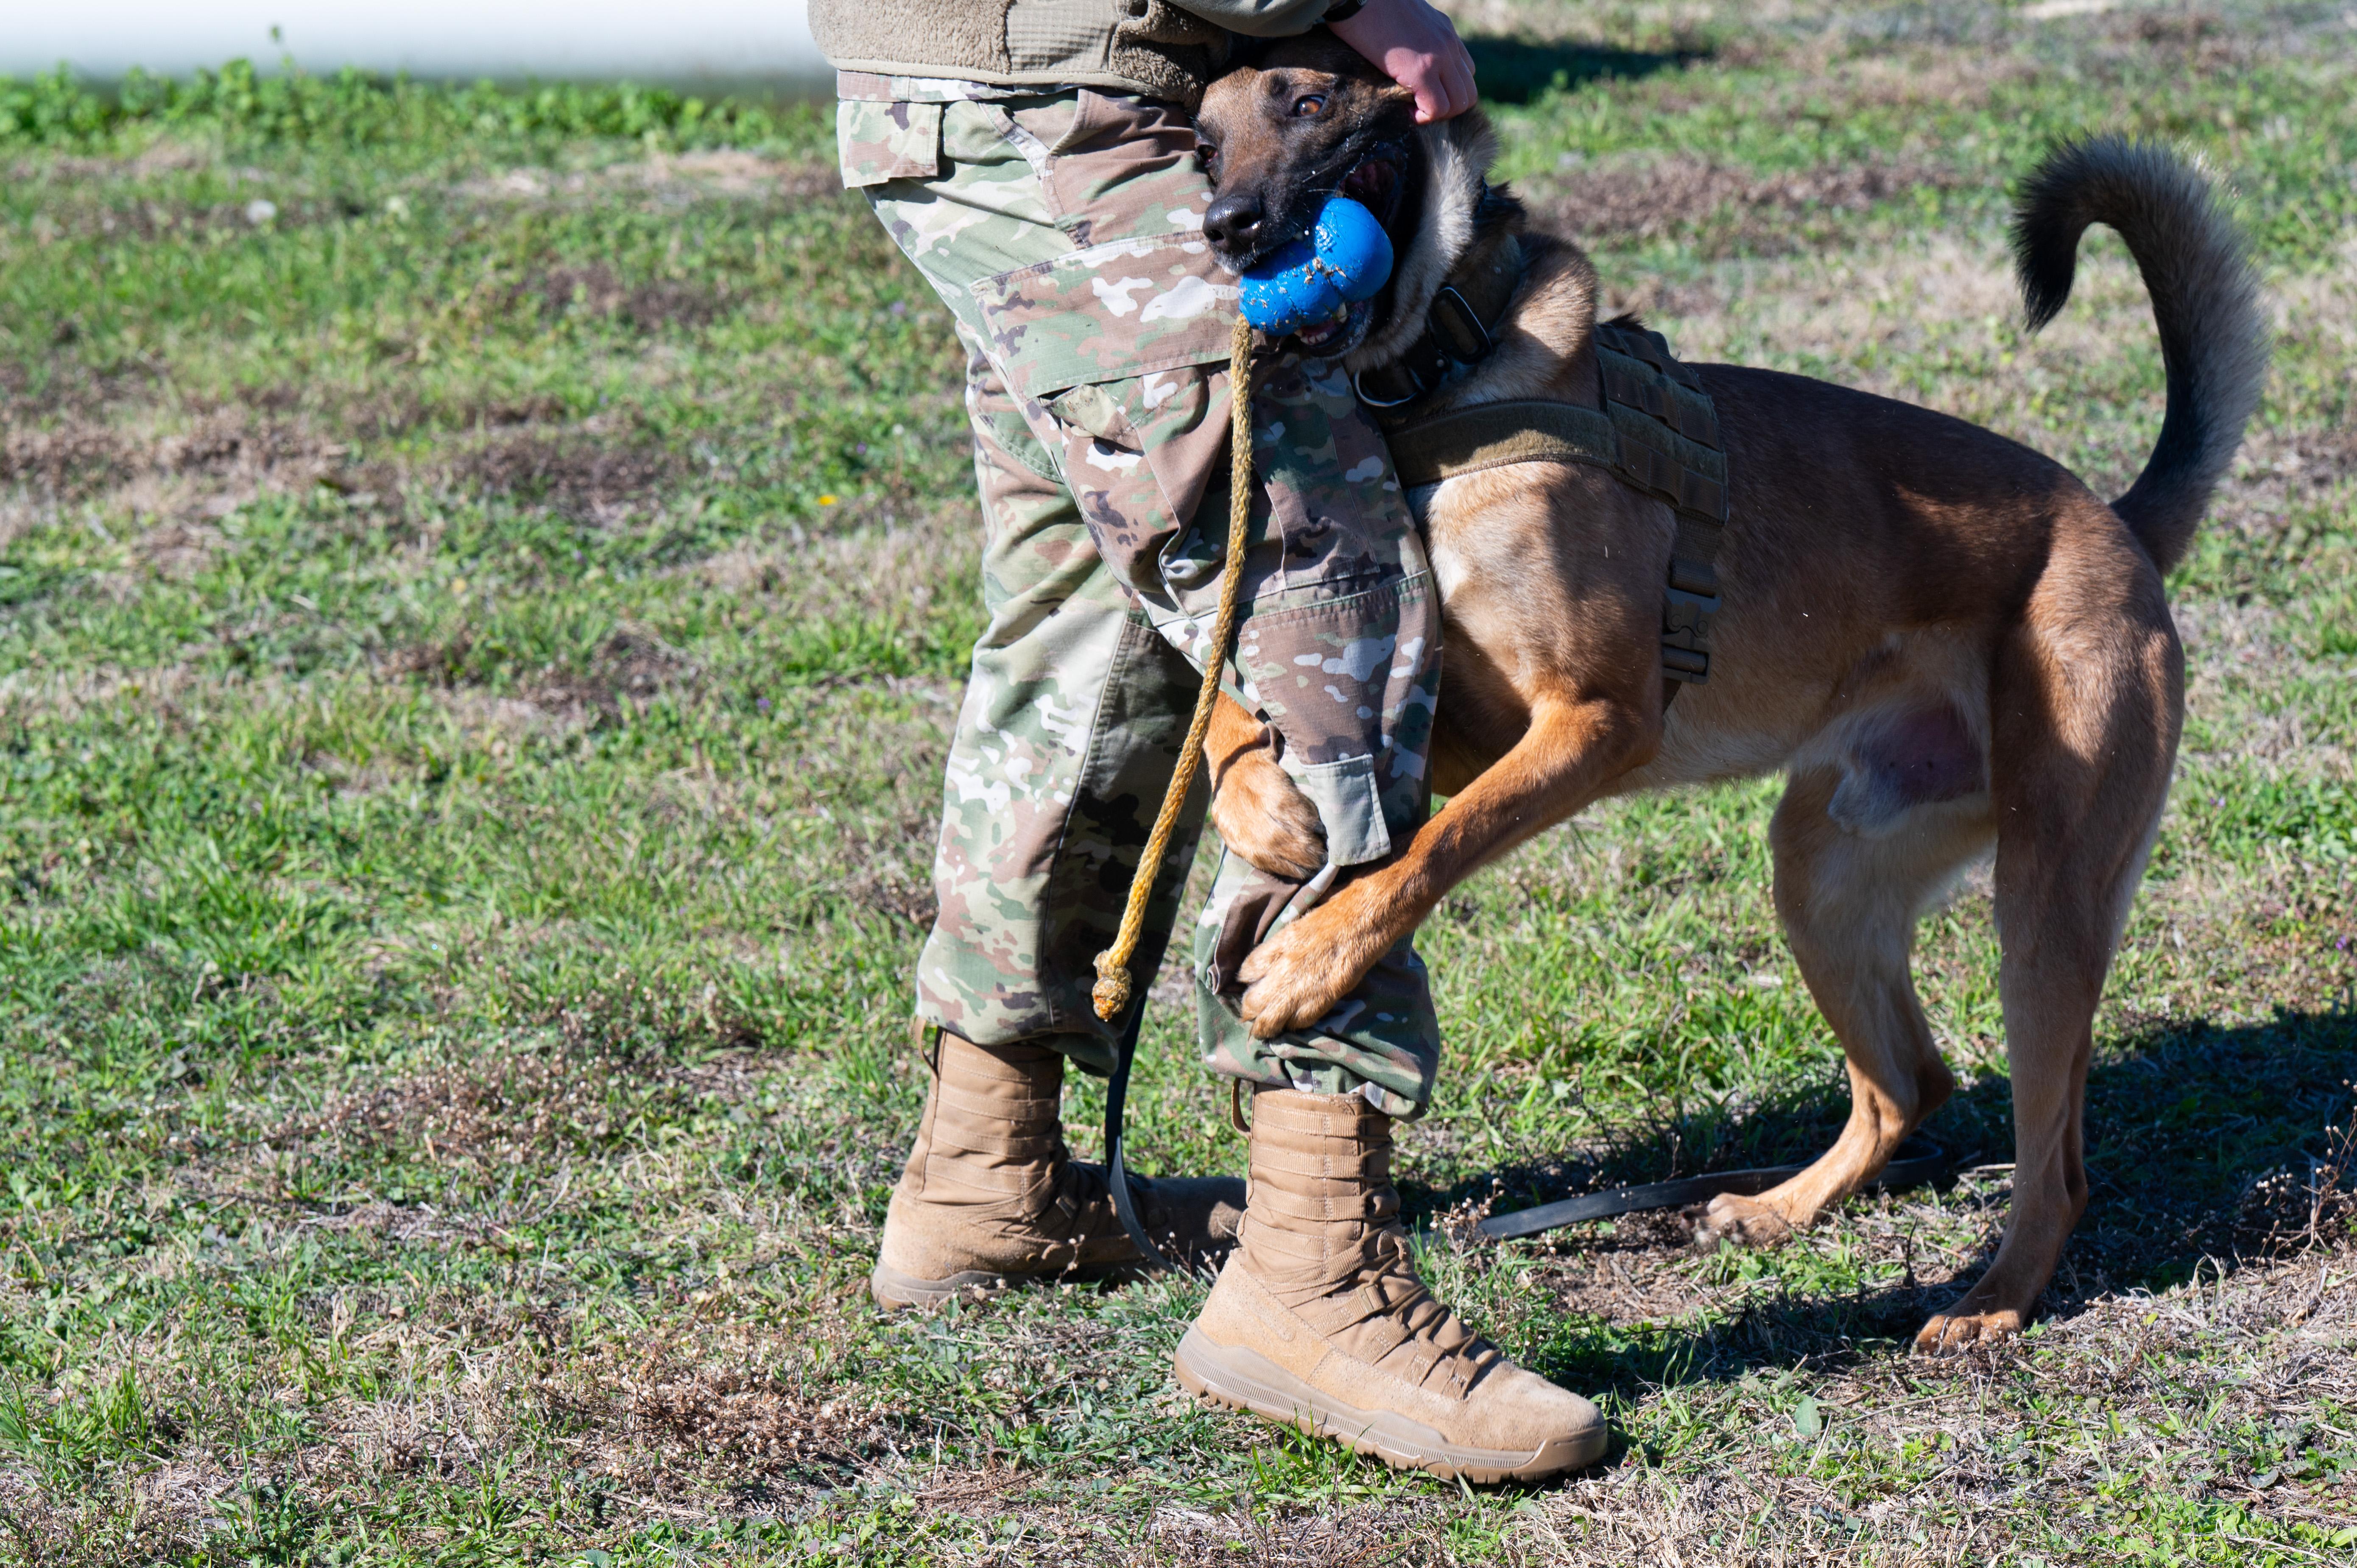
1699;773;1997;1245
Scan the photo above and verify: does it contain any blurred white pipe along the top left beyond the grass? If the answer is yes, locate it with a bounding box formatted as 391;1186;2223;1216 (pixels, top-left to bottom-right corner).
0;0;827;83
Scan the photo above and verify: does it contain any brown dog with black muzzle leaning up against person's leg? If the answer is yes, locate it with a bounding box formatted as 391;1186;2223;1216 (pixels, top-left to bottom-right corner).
1200;33;2265;1351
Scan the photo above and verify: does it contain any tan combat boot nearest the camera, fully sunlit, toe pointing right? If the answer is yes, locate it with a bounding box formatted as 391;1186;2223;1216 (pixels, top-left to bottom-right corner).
1178;1089;1605;1481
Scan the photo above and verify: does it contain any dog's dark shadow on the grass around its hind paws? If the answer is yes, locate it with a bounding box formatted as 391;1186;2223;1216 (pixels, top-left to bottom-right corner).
1442;1007;2357;1387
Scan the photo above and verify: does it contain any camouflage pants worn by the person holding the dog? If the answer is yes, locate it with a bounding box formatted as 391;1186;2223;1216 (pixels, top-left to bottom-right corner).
837;73;1440;1115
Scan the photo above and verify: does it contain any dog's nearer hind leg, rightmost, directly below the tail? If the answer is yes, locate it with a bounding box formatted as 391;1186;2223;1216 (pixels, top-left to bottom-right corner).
1916;523;2185;1351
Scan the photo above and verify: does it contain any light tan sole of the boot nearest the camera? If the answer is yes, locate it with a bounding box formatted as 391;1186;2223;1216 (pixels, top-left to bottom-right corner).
1176;1328;1612;1485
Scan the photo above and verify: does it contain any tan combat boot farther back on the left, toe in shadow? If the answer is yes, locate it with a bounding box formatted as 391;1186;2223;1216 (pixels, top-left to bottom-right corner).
867;1030;1245;1311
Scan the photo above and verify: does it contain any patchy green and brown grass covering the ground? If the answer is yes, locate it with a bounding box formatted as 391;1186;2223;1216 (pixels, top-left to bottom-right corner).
0;3;2357;1568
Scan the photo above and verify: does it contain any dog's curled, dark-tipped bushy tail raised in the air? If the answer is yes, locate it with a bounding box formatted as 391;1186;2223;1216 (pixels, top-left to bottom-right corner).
2013;137;2268;571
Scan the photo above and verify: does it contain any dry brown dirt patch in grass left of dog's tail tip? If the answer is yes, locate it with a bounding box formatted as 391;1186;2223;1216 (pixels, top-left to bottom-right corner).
1530;158;1963;255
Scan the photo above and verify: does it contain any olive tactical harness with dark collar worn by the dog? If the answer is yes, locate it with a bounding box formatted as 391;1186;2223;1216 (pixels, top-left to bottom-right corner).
1357;240;1728;705
